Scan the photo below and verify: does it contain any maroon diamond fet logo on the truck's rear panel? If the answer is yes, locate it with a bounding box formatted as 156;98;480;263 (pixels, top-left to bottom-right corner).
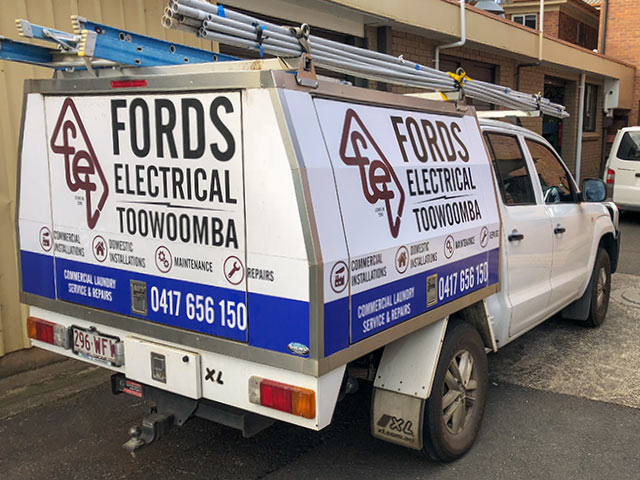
51;98;109;229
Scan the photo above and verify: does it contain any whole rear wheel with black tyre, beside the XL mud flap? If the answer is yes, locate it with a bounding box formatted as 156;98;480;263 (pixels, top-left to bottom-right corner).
423;320;489;462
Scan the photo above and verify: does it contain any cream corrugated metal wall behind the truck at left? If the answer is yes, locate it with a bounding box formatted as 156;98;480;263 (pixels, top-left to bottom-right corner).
0;0;218;356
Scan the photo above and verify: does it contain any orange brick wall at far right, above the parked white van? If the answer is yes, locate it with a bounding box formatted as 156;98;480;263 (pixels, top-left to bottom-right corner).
604;0;640;125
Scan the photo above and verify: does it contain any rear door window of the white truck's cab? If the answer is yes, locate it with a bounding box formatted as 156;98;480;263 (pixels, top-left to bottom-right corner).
484;132;536;206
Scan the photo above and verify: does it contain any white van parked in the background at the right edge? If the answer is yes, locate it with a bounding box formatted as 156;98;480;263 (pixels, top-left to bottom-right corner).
604;127;640;211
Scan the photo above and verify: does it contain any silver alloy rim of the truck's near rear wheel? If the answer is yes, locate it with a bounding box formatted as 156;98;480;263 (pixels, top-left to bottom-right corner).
442;349;478;435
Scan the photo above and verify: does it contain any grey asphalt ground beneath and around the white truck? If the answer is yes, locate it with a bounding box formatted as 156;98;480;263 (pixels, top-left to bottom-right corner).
0;215;640;480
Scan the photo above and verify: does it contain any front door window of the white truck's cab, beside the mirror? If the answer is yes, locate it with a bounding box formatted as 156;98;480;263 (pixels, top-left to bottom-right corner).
525;139;575;204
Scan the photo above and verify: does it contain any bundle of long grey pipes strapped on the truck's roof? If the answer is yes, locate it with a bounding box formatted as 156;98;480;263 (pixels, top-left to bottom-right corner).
162;0;569;118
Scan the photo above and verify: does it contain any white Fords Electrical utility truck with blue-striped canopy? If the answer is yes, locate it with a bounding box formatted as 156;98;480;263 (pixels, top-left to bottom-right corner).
8;10;619;461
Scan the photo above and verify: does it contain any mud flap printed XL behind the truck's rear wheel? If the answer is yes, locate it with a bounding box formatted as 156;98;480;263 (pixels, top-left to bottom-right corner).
371;388;425;450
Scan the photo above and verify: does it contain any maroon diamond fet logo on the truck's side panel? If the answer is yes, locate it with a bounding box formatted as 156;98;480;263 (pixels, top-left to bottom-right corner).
340;108;404;238
